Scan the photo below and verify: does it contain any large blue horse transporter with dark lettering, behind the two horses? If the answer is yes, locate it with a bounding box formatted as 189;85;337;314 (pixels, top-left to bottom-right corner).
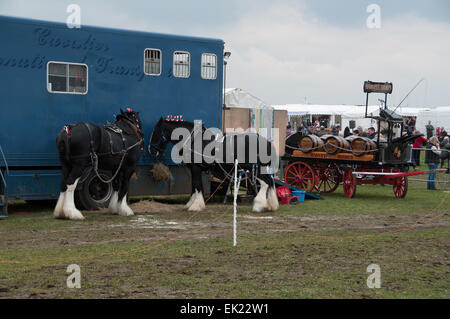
0;16;224;217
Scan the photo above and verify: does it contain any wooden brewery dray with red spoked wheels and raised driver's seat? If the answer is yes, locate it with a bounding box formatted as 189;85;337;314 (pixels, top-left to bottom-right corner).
282;82;423;198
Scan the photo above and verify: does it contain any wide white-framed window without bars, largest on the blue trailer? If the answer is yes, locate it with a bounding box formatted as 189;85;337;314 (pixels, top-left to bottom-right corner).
47;62;88;94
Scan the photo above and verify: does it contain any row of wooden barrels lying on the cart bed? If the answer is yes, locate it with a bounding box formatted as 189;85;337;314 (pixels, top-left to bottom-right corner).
298;135;376;156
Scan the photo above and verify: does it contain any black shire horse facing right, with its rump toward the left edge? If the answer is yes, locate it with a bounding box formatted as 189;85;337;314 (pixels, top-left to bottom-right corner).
53;108;144;220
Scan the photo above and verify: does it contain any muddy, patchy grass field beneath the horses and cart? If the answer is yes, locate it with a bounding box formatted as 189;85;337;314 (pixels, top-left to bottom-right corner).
0;174;450;298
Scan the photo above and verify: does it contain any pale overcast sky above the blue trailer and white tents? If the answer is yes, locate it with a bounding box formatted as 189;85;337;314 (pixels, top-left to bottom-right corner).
0;0;450;107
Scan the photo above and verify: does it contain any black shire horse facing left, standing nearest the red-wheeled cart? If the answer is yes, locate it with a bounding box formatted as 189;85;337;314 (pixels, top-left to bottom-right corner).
149;118;278;212
